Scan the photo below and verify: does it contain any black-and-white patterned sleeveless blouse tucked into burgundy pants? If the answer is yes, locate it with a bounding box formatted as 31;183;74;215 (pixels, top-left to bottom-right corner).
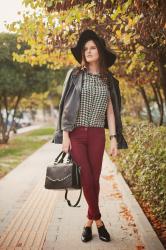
75;71;110;127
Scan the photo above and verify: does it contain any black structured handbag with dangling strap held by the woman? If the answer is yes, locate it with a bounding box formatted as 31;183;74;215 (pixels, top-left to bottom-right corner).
45;151;82;207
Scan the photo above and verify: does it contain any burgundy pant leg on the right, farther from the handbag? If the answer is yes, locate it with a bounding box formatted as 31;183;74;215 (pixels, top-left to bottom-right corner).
88;127;105;219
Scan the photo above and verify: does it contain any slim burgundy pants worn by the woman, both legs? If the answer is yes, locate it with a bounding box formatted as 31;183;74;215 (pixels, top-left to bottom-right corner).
69;126;105;220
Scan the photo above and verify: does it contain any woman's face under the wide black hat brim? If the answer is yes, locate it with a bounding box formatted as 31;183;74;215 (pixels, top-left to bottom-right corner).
84;40;99;63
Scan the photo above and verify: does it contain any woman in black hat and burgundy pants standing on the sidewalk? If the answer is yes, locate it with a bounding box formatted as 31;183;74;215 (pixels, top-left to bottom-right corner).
53;30;127;242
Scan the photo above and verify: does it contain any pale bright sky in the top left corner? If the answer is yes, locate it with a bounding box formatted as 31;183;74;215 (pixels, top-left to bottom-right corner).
0;0;25;32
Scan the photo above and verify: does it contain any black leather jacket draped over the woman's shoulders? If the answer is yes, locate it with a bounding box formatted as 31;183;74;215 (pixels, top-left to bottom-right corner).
52;67;128;149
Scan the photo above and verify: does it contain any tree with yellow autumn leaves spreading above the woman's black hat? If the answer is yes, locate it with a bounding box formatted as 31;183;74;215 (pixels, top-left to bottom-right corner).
8;0;166;123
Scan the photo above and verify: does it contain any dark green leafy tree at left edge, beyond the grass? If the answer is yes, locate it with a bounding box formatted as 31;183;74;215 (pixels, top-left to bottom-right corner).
0;33;56;143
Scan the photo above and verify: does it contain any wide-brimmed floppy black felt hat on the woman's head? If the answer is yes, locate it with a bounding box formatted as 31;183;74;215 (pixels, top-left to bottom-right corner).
71;29;116;67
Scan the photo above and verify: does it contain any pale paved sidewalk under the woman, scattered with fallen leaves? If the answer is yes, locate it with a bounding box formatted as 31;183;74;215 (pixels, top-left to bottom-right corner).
0;142;164;250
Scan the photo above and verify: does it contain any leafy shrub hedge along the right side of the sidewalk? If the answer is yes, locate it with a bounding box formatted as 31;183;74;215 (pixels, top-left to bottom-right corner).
106;117;166;222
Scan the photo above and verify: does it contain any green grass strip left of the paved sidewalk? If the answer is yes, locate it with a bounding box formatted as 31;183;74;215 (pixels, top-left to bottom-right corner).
0;127;55;177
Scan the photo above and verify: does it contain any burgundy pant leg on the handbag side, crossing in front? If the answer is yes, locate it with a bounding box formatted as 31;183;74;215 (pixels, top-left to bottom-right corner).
69;127;101;220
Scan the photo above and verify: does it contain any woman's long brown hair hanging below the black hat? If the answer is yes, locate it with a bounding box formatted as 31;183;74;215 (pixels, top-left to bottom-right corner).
81;39;109;83
